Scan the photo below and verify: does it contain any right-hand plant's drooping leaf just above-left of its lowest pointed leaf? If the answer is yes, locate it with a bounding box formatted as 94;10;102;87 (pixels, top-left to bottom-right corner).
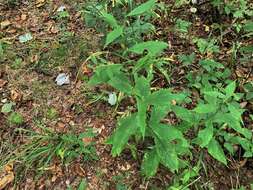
198;122;213;148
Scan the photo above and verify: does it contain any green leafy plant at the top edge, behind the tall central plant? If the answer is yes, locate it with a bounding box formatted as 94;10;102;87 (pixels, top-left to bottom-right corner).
84;0;157;47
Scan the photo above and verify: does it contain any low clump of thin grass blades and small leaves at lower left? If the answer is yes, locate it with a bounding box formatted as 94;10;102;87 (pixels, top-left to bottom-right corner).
0;123;98;178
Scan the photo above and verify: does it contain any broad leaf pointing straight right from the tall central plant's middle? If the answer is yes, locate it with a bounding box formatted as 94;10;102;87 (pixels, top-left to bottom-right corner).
146;89;186;106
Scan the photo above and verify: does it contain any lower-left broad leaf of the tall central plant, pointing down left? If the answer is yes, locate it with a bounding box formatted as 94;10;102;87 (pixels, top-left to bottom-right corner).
107;114;137;156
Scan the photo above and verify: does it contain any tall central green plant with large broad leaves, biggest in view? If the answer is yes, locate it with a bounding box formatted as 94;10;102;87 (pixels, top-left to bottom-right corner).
89;0;190;177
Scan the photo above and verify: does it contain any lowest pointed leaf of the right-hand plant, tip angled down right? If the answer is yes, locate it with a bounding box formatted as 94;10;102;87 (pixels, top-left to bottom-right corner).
207;138;227;165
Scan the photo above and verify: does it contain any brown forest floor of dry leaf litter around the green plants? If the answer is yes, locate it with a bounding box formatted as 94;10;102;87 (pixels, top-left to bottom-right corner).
0;0;253;190
